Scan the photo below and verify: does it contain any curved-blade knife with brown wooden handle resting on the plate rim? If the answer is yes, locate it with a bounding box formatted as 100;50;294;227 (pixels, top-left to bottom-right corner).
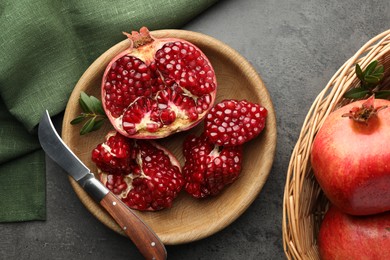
38;110;167;260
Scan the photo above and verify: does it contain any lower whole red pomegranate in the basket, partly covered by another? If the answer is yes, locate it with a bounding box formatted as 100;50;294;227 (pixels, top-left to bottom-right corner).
318;207;390;260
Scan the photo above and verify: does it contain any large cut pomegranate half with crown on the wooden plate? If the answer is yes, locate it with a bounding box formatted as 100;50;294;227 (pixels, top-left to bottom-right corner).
101;27;217;139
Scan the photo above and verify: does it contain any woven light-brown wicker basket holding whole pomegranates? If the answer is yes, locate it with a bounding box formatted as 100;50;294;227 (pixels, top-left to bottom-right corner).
283;30;390;259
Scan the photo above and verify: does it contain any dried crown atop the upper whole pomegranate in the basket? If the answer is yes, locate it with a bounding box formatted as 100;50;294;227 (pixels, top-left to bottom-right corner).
342;95;387;124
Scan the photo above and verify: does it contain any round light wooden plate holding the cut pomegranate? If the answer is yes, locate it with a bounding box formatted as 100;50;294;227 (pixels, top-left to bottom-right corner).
62;30;276;245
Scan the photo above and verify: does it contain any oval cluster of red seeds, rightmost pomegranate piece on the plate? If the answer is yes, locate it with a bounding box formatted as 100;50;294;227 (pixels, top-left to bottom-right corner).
205;99;268;146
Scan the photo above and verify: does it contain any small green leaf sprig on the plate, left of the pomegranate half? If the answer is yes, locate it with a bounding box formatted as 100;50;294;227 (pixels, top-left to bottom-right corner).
70;91;107;135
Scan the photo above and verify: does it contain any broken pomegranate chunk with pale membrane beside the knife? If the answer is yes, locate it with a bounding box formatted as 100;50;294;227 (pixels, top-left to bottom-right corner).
92;131;184;211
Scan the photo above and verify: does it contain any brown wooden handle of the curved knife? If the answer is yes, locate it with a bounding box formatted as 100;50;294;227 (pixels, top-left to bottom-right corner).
100;192;167;260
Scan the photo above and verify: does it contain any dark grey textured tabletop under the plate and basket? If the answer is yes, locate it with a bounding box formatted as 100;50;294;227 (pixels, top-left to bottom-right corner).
0;0;390;259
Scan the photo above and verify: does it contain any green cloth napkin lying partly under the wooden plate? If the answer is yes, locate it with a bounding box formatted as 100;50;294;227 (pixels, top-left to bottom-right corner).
0;0;217;222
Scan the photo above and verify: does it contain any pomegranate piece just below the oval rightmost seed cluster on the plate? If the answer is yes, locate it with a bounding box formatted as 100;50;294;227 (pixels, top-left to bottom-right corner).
183;134;242;198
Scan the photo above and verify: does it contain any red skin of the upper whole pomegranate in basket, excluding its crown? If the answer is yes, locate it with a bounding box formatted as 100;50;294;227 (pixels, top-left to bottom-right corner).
311;99;390;215
